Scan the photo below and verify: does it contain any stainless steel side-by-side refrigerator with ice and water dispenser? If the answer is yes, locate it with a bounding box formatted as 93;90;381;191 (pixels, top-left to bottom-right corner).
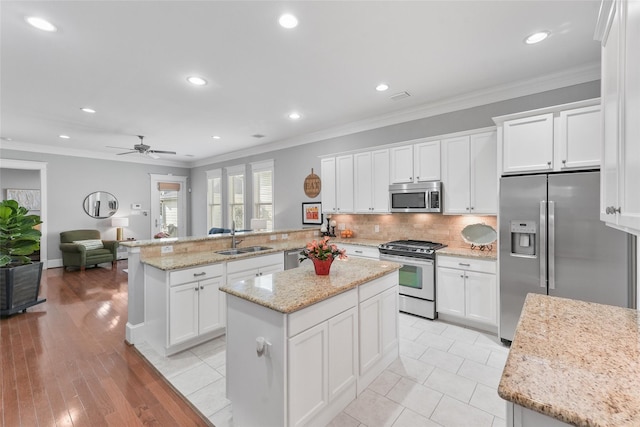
498;171;635;342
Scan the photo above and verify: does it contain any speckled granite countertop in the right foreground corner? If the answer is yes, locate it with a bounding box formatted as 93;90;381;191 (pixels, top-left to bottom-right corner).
498;294;640;426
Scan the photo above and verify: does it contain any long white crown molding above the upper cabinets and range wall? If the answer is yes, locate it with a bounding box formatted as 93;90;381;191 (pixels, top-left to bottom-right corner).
191;63;600;167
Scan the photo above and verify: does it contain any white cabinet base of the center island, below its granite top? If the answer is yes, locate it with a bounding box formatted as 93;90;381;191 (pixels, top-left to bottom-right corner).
227;272;399;427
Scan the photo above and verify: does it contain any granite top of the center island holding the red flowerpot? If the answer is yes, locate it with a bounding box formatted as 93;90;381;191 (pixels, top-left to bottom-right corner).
220;257;400;313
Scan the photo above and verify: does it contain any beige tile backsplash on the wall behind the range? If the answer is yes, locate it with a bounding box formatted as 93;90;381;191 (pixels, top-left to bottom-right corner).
331;213;498;250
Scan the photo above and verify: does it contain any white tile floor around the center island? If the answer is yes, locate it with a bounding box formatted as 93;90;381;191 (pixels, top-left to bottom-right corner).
137;313;509;427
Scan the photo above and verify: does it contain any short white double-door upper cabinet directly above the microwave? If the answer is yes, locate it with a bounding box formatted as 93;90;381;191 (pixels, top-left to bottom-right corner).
390;141;440;184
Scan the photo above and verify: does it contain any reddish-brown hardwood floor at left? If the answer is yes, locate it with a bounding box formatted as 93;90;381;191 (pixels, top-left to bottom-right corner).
0;261;210;427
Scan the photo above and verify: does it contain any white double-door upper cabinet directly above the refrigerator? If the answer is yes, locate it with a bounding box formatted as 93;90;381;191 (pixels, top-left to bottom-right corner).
494;99;602;174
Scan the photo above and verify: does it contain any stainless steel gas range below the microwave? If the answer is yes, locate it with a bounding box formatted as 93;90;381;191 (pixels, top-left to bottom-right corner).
378;240;446;319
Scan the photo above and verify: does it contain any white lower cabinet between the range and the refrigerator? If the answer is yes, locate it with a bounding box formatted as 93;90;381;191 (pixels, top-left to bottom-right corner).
436;255;498;327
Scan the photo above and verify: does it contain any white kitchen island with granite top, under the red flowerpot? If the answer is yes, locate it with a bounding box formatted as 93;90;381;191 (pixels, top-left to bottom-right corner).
220;258;400;427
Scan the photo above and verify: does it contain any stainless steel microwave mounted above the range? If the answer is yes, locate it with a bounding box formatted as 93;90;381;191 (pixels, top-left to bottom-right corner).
389;181;442;212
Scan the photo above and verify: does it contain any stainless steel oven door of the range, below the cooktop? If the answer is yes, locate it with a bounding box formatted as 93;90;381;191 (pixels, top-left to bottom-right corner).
380;254;435;301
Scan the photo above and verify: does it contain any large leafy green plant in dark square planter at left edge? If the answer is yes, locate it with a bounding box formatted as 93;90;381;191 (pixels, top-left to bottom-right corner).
0;200;46;316
